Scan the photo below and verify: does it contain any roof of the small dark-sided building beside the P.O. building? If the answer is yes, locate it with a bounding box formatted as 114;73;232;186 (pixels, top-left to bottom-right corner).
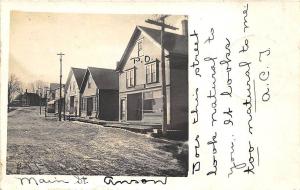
80;67;119;92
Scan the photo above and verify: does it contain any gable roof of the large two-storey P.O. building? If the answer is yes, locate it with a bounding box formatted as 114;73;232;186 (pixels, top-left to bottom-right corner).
116;26;188;71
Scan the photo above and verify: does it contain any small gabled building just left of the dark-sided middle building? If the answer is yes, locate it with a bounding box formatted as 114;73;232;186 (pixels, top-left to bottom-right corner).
65;67;86;116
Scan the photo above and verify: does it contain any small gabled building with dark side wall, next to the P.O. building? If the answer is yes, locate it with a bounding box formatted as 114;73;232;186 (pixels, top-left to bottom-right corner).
80;67;119;121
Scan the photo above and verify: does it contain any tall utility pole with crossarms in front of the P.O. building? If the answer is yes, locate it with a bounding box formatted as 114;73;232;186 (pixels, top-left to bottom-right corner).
145;15;178;134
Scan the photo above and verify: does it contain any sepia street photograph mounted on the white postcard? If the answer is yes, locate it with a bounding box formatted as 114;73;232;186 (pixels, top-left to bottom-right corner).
6;11;188;177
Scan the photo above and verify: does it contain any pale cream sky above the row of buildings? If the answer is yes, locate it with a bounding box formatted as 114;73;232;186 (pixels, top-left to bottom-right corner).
9;11;184;87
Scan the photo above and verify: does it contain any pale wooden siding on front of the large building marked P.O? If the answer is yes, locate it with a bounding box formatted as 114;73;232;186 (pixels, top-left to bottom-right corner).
119;34;171;124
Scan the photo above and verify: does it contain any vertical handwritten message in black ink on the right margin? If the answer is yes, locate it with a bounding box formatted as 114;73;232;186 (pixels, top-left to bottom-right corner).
189;4;271;178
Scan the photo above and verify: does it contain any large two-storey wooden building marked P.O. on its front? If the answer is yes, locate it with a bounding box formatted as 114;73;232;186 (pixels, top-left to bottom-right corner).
116;21;188;134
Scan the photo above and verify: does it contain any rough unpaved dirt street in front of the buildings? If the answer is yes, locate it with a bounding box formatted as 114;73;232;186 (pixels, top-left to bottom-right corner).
7;107;187;176
